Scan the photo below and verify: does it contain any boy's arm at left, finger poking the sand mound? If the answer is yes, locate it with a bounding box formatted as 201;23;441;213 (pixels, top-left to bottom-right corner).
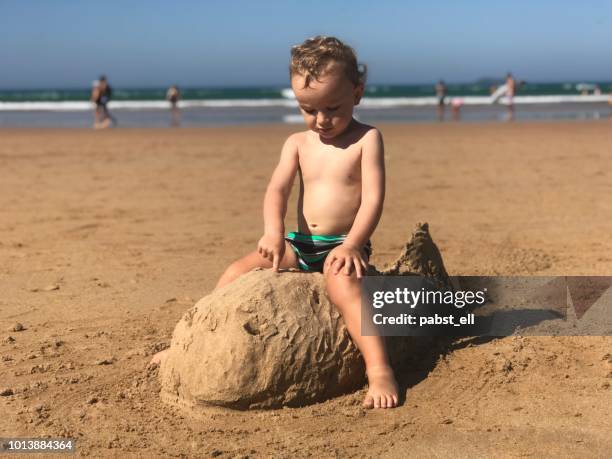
258;134;299;270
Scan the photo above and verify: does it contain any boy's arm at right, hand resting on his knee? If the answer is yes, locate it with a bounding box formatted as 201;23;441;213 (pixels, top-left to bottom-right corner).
326;129;385;277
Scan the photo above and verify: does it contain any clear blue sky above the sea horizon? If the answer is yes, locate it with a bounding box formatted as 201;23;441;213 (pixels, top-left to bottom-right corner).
0;0;612;89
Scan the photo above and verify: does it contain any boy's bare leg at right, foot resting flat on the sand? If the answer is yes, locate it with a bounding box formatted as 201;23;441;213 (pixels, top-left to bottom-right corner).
325;267;398;408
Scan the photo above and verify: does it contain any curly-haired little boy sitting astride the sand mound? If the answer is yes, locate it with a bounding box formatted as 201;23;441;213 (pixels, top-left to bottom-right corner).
152;36;398;408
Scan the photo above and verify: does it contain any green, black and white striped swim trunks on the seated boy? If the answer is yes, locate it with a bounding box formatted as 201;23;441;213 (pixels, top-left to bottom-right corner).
285;232;372;273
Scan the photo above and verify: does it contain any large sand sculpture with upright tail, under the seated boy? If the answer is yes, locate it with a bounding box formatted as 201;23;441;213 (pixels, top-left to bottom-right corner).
160;223;449;409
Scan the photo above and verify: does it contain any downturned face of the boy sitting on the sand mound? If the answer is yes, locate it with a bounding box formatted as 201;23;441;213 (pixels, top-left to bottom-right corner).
291;64;363;139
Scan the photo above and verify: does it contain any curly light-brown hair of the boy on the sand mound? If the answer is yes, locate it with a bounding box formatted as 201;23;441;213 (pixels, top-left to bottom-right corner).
289;35;367;88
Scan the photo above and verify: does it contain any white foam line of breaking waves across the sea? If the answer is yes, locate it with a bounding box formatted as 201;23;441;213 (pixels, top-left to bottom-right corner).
0;91;609;112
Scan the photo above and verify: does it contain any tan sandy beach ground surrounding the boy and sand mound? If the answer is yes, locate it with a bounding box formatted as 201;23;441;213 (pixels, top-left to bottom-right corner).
0;121;612;457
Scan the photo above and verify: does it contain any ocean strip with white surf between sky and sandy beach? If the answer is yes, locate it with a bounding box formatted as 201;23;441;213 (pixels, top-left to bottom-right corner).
0;79;612;127
